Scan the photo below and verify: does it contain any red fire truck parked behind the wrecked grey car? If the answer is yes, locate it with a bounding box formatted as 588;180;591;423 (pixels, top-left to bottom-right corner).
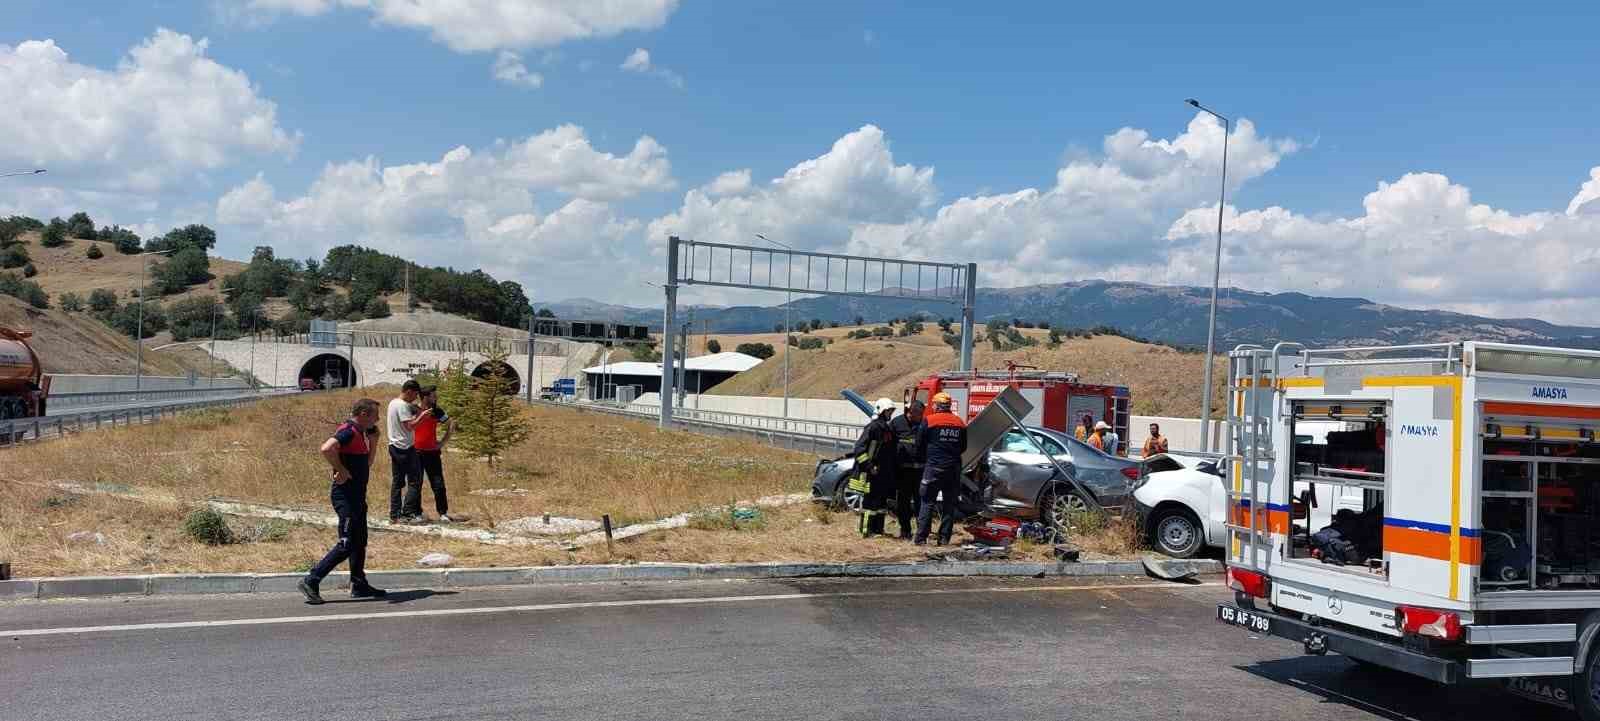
904;363;1128;456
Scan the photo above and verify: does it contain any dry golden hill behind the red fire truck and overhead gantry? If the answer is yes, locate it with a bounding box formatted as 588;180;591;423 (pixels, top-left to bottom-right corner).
690;325;1226;417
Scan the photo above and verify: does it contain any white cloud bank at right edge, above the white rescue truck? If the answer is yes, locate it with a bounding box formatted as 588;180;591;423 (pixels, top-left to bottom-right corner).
1166;168;1600;325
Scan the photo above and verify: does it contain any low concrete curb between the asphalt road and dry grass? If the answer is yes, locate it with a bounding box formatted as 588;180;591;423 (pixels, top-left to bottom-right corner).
0;560;1222;601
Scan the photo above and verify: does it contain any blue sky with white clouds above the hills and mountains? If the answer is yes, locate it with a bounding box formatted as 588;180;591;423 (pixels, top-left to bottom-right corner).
0;0;1600;320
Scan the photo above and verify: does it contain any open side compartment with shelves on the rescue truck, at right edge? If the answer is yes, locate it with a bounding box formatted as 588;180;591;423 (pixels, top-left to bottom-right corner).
1478;412;1600;590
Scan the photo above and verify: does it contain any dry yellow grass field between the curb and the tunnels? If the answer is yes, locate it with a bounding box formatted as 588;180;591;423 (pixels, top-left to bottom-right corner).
0;388;1131;577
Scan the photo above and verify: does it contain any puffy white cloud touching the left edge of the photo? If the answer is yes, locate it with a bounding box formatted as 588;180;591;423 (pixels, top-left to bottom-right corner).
0;29;299;192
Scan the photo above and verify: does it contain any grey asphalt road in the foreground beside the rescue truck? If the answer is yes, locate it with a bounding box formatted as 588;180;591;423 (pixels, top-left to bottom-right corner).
0;579;1566;721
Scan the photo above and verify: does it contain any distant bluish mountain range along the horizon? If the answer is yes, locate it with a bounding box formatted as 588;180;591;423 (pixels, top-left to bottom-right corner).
534;280;1600;349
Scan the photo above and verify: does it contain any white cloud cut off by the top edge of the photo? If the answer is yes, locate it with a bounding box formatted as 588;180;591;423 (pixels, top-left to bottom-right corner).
235;0;678;53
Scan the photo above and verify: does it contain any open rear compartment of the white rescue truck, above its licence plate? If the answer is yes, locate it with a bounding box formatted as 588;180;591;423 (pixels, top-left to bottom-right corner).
1290;401;1389;576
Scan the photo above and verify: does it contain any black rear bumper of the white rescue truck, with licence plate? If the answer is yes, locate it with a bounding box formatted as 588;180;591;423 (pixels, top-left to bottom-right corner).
1216;603;1466;684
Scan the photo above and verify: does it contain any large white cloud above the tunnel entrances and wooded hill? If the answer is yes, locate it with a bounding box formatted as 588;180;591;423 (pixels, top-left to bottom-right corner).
216;125;674;278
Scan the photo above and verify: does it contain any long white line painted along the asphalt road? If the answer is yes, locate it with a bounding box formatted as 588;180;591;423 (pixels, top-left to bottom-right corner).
0;582;1221;638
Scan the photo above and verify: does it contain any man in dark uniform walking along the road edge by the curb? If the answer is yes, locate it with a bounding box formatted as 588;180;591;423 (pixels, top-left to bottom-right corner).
299;398;387;604
